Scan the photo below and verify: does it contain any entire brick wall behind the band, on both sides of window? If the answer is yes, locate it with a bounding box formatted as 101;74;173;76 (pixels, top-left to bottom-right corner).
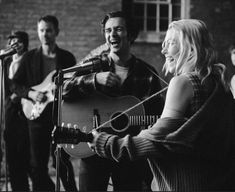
0;0;235;80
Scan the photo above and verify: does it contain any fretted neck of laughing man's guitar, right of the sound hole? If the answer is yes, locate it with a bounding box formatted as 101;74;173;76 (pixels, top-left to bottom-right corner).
129;115;158;126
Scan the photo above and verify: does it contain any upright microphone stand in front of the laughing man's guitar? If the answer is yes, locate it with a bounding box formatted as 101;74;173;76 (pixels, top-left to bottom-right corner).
52;70;63;192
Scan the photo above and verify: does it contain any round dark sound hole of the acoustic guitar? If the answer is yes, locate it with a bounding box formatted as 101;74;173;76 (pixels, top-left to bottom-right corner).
111;112;129;132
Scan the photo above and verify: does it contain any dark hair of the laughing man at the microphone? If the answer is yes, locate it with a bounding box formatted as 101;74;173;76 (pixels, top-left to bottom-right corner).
101;11;139;43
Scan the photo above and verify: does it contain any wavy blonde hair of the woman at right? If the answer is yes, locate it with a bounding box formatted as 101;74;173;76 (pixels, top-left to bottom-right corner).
164;19;226;85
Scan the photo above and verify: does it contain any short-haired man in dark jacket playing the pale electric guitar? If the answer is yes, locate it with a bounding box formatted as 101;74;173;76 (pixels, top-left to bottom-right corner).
12;15;77;191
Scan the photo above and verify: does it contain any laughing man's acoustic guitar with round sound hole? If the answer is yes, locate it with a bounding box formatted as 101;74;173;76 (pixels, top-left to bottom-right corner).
59;93;157;158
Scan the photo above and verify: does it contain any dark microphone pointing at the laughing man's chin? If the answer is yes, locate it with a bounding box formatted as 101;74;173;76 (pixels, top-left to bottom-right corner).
62;57;110;75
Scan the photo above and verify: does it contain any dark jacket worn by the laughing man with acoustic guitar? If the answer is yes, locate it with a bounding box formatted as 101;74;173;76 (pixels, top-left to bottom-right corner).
64;56;164;115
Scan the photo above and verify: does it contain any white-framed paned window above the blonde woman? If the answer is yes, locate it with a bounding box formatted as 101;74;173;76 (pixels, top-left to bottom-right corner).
123;0;189;42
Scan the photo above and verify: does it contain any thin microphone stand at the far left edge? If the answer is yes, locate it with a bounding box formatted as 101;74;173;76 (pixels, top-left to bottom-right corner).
0;57;8;191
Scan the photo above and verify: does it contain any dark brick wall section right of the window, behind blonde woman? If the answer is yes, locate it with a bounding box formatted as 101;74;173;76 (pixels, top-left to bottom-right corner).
191;0;235;62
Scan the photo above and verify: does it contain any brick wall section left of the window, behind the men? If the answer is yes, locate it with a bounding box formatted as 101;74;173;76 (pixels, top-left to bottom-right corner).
0;0;121;60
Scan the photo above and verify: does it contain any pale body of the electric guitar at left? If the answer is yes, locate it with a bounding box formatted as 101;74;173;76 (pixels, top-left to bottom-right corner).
21;71;55;120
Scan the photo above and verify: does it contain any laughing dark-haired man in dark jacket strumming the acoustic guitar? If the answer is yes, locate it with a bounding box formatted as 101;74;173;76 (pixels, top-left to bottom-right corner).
64;11;163;191
